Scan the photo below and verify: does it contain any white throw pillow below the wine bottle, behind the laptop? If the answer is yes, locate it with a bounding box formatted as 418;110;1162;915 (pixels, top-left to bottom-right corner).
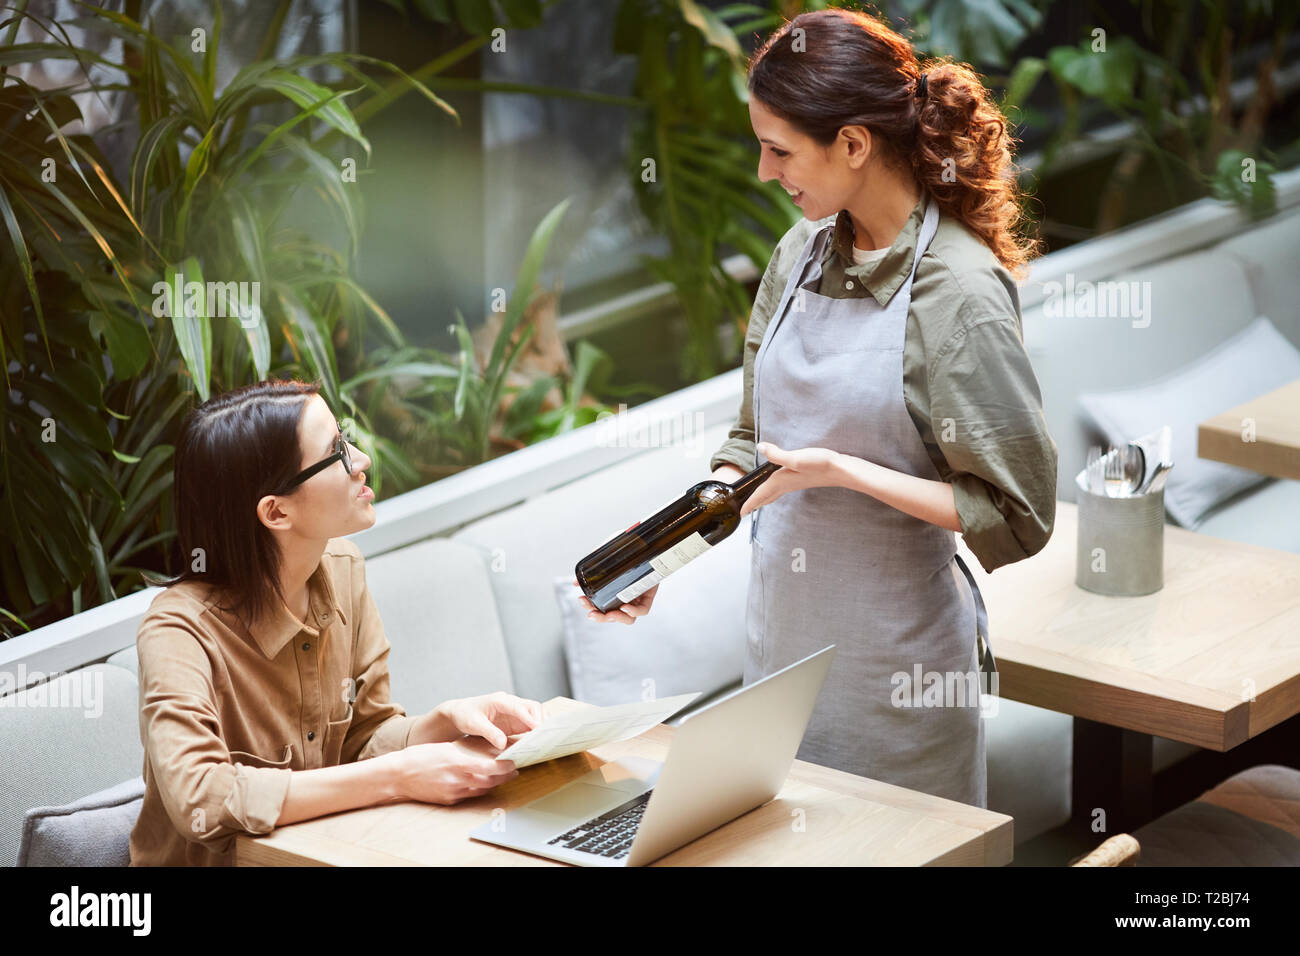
555;515;750;706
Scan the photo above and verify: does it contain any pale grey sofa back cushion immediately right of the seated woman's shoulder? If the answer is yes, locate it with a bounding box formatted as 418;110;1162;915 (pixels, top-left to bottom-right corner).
365;538;515;715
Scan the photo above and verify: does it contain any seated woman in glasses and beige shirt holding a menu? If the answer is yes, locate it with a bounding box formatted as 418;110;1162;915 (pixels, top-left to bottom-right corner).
131;381;541;866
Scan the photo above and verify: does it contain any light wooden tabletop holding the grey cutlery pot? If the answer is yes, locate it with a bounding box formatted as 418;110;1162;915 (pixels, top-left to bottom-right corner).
967;501;1300;750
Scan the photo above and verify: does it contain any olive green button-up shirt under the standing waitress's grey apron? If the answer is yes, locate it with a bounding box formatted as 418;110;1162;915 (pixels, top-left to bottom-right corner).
710;195;1057;571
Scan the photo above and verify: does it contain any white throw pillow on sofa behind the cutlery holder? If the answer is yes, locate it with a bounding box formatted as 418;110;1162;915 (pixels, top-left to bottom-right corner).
1079;316;1300;528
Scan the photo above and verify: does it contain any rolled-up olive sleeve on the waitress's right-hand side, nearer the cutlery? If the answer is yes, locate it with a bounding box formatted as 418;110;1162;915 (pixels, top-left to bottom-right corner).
930;316;1057;571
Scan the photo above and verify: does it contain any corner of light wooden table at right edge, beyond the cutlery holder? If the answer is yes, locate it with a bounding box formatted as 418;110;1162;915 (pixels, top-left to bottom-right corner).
1196;381;1300;480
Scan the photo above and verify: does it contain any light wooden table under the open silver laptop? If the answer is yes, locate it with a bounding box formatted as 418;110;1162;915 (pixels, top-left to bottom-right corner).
235;697;1013;866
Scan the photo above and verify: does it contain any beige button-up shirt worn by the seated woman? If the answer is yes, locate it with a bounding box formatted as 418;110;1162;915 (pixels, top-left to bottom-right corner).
131;538;416;866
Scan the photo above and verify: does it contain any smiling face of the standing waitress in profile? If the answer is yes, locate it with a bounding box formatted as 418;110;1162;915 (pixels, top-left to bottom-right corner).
749;96;871;221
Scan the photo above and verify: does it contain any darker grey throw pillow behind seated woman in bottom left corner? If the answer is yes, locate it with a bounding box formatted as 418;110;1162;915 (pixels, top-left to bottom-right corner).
18;777;144;866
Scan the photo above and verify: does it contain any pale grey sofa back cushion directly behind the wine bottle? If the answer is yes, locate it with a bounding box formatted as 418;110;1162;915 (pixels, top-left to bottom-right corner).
452;421;744;700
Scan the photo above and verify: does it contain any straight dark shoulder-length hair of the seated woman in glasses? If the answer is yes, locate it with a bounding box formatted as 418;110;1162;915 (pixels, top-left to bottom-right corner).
157;381;320;629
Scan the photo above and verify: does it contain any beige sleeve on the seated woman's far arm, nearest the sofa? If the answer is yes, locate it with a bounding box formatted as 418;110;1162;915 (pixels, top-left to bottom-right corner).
341;553;417;763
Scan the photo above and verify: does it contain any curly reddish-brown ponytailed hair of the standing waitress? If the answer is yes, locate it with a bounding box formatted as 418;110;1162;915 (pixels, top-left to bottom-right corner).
749;8;1037;278
